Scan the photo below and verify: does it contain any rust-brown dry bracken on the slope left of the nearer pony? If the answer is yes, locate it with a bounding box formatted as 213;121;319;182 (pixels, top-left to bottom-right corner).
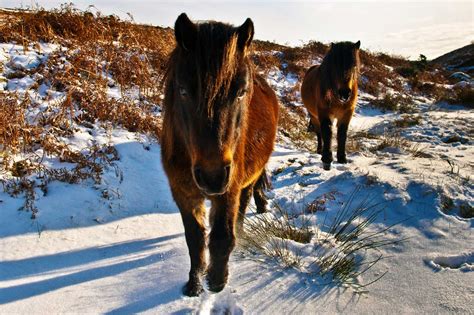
0;5;168;218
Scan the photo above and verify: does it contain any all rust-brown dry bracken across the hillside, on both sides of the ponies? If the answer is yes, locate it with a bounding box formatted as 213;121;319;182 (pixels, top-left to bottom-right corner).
0;4;462;222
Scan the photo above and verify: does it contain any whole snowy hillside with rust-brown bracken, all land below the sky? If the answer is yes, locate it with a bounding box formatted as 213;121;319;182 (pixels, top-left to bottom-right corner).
0;8;474;314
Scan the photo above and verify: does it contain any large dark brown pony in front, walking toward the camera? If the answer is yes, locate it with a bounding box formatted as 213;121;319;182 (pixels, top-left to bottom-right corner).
162;13;278;296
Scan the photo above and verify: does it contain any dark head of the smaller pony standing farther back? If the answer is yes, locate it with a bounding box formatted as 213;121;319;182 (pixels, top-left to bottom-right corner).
323;41;360;103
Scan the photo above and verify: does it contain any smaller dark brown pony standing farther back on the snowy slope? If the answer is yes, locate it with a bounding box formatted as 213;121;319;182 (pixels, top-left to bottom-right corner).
301;41;360;170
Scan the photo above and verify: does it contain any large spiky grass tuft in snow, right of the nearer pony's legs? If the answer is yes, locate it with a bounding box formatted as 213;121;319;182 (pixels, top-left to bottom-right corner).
239;187;403;292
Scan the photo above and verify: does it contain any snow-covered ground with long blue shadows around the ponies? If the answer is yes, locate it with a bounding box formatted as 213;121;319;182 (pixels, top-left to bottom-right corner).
0;44;474;314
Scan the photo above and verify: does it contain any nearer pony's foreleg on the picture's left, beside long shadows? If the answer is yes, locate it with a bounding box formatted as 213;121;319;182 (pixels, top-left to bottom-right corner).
171;187;206;296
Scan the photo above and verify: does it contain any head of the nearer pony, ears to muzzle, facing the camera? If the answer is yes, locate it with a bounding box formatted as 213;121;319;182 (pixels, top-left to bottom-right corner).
165;13;254;195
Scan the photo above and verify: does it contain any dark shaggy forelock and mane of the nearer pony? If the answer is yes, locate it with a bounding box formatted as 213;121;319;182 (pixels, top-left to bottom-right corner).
166;21;241;117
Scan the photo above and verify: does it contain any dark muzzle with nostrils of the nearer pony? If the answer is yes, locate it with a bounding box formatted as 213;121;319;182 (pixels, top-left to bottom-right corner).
193;164;231;196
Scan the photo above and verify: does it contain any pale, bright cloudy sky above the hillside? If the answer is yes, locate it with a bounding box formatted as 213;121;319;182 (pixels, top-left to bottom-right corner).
0;0;474;59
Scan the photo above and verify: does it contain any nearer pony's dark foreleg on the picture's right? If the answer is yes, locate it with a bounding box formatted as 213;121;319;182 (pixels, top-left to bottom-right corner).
207;190;240;292
